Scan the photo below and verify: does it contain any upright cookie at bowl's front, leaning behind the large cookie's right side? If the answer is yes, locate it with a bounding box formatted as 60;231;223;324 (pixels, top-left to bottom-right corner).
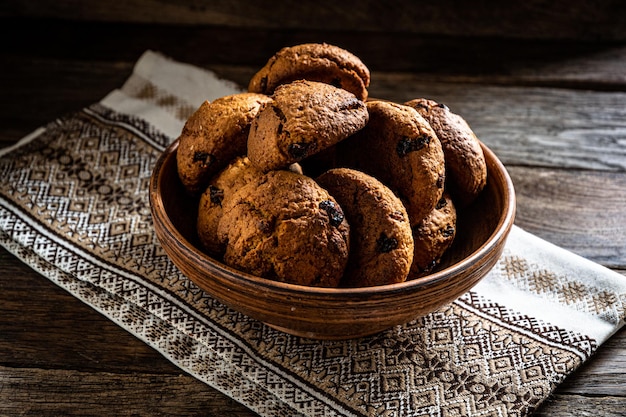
317;168;413;287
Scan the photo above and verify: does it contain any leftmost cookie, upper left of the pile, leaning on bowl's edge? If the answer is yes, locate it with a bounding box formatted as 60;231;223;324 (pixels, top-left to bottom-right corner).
176;93;270;195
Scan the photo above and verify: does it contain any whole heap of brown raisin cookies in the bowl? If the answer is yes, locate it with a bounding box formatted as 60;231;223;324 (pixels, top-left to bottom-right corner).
176;44;487;287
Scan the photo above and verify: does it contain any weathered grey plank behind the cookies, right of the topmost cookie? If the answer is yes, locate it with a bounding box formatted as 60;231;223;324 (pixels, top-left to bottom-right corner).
370;80;626;171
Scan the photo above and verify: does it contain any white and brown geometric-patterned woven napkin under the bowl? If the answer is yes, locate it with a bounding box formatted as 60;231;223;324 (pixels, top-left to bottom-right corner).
0;52;626;416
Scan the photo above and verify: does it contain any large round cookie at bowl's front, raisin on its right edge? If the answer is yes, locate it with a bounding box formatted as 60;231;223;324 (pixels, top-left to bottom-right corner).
218;171;350;287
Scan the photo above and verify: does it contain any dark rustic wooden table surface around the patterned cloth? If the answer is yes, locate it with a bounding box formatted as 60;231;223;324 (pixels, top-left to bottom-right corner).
0;1;626;416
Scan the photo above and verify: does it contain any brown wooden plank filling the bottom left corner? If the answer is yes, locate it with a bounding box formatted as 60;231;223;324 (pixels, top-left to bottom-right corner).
0;366;256;417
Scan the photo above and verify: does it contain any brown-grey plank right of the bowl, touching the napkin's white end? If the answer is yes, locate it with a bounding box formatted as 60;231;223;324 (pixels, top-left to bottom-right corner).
508;166;626;268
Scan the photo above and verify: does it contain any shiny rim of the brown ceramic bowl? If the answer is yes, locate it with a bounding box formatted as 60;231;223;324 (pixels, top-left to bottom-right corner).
149;139;516;299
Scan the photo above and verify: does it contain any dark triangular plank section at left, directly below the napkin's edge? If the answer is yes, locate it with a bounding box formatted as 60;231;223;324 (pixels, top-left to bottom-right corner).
0;248;174;374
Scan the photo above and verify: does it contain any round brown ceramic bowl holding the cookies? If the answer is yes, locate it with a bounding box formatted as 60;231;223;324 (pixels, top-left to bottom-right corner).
150;142;515;339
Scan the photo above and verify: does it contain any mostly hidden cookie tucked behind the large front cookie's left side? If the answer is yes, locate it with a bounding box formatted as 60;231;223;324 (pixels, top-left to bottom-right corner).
196;156;263;256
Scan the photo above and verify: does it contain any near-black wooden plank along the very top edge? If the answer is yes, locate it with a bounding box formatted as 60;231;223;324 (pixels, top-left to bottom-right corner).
0;0;626;40
